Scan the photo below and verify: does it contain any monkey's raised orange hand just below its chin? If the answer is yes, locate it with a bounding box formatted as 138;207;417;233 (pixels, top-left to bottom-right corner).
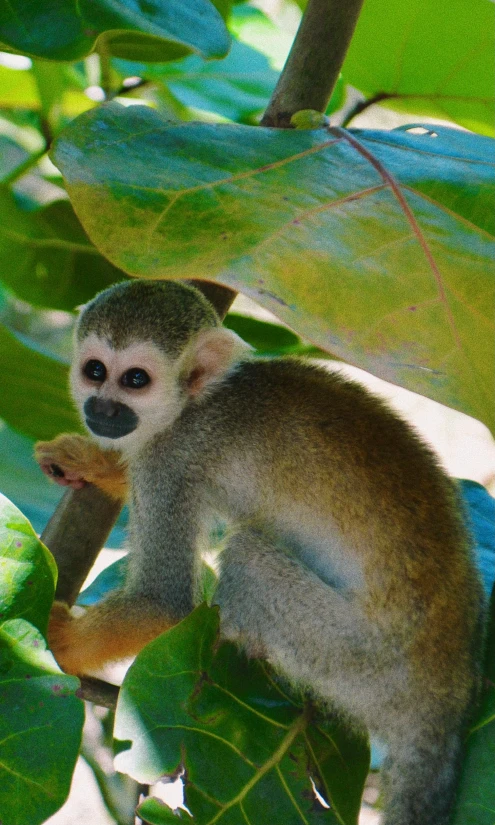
34;433;128;501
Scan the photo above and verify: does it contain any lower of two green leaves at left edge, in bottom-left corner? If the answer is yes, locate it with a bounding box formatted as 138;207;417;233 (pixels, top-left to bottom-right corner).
0;619;84;825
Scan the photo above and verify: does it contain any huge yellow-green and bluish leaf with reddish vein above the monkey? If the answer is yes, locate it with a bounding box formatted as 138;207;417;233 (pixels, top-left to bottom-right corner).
54;104;495;426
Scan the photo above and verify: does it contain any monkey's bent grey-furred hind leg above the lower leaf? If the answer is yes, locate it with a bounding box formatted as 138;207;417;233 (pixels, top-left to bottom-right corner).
214;529;386;688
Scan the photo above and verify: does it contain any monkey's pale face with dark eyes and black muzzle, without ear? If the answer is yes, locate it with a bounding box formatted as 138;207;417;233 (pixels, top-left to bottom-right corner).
71;333;184;455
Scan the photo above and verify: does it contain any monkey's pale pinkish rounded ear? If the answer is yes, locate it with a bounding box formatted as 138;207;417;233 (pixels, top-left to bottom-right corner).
185;327;253;396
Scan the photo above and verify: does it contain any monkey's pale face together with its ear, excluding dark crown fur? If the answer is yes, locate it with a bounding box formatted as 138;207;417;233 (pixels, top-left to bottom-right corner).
70;327;251;458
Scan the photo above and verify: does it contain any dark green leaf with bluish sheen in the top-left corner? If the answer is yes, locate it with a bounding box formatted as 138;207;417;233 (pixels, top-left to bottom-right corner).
0;0;229;61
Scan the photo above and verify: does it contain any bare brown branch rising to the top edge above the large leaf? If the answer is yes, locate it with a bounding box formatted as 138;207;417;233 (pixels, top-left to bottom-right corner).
261;0;363;128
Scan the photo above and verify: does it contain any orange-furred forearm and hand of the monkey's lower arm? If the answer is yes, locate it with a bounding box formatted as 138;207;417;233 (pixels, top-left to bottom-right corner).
48;592;175;676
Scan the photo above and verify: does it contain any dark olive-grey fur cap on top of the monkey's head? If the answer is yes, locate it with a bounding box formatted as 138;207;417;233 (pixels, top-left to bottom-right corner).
76;280;220;357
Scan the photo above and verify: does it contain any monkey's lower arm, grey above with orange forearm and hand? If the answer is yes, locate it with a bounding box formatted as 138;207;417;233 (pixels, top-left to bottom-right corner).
48;451;200;675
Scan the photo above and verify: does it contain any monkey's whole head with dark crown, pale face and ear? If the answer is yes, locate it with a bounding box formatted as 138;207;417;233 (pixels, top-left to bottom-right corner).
71;281;251;457
